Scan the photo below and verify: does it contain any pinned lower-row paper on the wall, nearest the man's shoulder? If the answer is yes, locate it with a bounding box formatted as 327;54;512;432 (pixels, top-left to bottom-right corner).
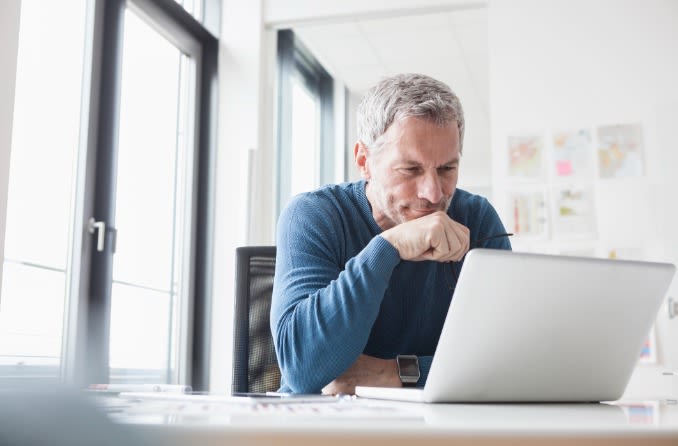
509;189;548;237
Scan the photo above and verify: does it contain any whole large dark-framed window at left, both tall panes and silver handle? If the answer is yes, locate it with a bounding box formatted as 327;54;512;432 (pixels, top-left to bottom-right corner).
0;0;218;390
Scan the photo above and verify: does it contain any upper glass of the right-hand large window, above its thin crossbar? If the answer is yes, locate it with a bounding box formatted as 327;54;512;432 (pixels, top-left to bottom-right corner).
113;12;181;290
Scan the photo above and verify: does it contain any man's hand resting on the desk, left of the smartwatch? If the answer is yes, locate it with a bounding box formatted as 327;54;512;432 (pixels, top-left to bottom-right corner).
322;355;402;395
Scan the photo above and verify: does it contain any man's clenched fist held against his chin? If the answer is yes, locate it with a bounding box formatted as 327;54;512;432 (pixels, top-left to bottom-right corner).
381;211;469;262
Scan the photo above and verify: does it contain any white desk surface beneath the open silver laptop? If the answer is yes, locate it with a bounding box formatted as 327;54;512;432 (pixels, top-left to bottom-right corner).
98;399;678;446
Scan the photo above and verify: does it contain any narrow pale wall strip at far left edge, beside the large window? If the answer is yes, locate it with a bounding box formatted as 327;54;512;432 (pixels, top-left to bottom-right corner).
0;0;21;294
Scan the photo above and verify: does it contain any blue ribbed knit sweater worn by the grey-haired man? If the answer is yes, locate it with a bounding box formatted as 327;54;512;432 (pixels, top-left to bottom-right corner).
271;181;511;393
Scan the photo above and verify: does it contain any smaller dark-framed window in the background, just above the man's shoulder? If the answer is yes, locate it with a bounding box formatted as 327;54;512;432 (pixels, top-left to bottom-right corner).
277;30;334;213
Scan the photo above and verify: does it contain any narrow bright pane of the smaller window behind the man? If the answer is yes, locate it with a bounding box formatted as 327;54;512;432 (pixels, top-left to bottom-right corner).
290;77;320;196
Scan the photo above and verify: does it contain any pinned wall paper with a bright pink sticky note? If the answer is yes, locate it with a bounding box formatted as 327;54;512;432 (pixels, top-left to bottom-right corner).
553;129;593;178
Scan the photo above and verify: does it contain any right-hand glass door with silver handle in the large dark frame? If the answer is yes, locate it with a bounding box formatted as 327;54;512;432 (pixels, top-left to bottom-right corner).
88;3;200;383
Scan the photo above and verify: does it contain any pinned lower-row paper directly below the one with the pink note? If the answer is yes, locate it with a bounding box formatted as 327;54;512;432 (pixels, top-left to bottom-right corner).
553;186;596;237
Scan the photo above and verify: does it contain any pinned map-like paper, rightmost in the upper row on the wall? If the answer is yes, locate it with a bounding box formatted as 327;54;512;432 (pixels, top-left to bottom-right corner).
598;124;643;178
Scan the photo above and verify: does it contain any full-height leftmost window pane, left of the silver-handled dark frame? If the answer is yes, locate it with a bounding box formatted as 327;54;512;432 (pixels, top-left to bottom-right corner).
0;1;87;375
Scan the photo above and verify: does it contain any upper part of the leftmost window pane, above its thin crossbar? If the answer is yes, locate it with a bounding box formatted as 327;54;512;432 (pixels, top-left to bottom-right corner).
5;1;85;268
